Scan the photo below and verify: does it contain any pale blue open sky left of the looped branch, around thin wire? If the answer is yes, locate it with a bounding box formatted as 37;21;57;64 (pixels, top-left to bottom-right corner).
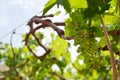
0;0;48;43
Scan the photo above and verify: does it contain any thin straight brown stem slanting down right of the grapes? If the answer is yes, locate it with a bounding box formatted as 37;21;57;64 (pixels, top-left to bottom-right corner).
100;15;117;80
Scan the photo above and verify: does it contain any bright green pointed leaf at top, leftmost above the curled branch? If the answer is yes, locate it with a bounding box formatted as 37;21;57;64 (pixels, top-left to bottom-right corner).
42;0;56;15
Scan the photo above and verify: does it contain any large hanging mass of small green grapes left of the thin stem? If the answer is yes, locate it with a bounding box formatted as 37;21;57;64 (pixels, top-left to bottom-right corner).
65;11;109;69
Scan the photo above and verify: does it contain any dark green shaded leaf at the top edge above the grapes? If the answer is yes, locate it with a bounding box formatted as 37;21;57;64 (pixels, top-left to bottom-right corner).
84;0;111;19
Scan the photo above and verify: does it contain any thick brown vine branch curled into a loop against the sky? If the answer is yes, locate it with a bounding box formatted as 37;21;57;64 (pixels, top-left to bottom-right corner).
25;14;73;61
